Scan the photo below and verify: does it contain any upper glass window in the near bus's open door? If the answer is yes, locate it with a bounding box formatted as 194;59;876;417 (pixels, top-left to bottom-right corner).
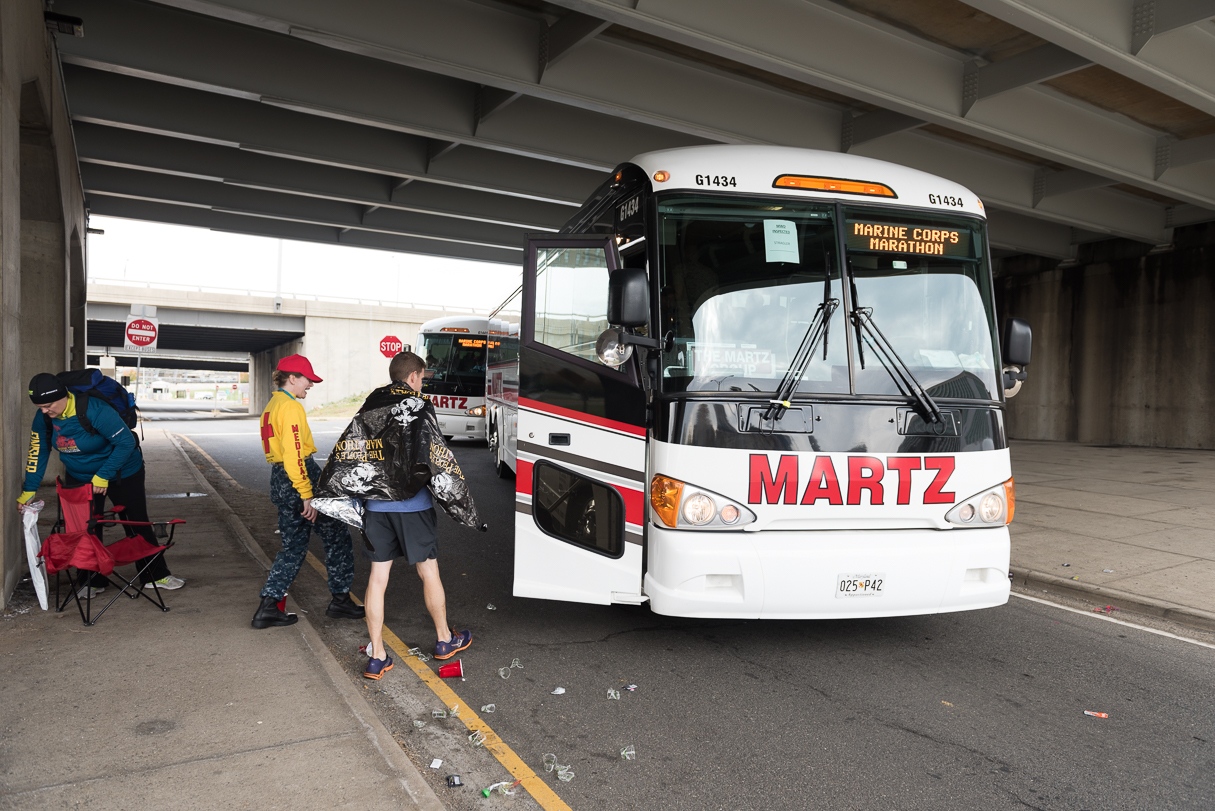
535;248;609;364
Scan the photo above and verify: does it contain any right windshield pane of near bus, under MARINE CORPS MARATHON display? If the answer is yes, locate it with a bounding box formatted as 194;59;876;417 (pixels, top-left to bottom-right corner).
844;207;999;400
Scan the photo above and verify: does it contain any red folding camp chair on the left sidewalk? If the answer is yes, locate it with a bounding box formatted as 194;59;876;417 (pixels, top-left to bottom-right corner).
39;479;186;625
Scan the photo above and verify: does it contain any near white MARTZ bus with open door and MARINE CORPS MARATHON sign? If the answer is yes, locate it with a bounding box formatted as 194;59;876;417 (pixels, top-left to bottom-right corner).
488;146;1030;618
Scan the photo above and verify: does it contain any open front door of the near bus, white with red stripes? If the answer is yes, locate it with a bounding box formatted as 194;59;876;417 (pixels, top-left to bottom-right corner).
514;235;646;604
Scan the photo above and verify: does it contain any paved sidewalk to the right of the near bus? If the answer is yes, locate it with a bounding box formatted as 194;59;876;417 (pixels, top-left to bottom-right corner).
1011;441;1215;631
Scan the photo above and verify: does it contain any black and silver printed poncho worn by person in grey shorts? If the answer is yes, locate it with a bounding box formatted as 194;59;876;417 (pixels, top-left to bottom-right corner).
312;383;484;531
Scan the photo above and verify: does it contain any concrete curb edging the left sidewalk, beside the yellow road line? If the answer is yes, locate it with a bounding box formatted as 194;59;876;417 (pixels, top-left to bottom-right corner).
164;430;447;811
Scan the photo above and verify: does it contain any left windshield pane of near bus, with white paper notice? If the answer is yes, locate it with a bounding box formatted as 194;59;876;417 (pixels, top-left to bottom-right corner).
657;197;849;394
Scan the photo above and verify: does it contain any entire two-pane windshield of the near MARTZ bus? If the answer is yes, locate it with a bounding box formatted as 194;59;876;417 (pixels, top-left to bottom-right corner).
656;196;999;400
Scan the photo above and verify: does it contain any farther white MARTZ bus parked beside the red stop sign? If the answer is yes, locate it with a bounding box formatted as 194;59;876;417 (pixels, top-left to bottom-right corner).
414;315;488;439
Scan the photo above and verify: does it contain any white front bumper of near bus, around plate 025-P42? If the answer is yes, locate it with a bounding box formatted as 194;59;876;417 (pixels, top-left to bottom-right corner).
644;524;1010;619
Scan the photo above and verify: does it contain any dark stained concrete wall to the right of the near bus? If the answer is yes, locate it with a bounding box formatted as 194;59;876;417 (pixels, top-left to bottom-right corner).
998;224;1215;449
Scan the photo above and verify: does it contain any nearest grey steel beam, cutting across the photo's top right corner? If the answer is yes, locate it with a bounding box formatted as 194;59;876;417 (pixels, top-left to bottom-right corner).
966;0;1215;116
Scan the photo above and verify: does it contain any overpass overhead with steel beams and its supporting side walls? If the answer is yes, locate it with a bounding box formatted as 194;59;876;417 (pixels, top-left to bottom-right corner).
0;0;1215;603
